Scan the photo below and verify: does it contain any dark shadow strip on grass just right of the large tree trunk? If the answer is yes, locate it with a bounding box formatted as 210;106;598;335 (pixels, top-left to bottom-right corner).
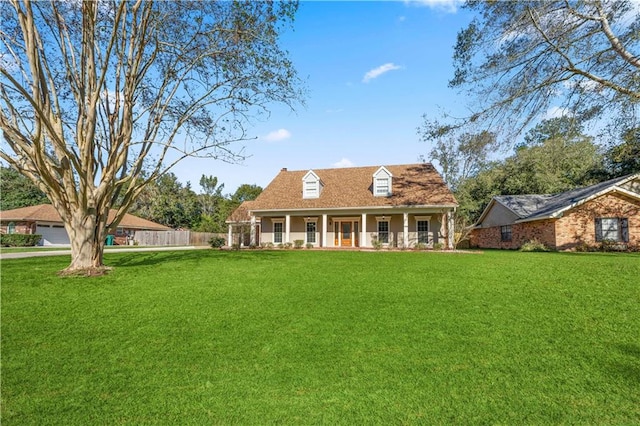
105;249;284;268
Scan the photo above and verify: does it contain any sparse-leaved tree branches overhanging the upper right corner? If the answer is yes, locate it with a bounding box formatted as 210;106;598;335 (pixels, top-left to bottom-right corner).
449;0;640;142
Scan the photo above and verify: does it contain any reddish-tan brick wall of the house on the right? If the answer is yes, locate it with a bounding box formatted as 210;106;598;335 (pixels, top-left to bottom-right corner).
471;193;640;250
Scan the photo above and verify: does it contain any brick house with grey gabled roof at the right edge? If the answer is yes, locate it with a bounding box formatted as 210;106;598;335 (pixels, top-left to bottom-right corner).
471;173;640;250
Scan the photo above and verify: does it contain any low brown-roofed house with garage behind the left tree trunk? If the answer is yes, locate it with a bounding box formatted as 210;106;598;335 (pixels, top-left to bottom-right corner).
0;204;171;246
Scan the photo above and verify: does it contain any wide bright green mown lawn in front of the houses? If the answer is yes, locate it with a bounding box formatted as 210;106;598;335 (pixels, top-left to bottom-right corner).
1;250;640;425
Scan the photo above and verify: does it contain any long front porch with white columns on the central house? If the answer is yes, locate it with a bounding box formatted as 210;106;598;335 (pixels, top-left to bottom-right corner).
239;209;453;249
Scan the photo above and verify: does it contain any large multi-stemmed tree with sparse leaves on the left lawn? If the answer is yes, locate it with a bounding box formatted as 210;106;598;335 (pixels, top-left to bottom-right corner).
0;0;301;272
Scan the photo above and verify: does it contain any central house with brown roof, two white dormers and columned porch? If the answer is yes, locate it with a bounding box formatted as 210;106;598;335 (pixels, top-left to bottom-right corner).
227;164;458;248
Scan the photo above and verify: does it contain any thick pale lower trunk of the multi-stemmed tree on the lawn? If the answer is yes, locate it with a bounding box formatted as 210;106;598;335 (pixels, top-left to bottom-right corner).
62;211;108;275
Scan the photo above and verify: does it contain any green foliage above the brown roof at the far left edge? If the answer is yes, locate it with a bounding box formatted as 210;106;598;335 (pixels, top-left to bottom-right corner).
0;166;49;211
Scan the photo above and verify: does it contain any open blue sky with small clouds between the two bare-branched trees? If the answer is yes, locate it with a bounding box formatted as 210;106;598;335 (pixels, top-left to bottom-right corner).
172;0;471;193
